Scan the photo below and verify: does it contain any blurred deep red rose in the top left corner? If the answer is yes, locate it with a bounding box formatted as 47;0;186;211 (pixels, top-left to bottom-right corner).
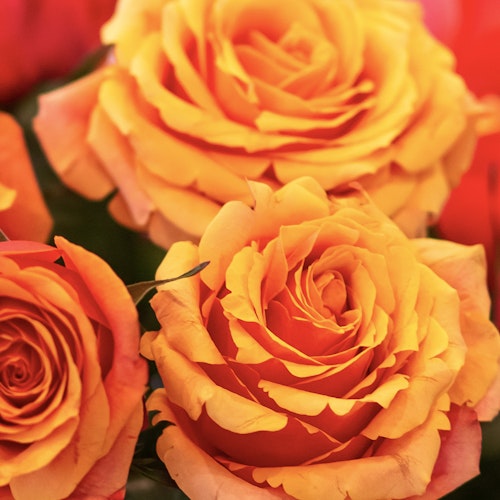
0;0;116;102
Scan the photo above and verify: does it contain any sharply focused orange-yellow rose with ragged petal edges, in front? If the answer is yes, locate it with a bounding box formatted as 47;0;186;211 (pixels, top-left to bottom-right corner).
141;178;500;500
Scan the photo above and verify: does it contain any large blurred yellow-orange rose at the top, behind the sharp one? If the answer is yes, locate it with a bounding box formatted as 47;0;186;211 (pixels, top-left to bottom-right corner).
35;0;475;246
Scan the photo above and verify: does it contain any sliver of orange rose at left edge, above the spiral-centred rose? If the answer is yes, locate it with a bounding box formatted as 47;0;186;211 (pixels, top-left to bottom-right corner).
0;113;52;241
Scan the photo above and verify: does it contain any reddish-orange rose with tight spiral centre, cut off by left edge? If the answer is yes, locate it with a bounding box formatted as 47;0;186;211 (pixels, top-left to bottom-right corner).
0;238;147;500
